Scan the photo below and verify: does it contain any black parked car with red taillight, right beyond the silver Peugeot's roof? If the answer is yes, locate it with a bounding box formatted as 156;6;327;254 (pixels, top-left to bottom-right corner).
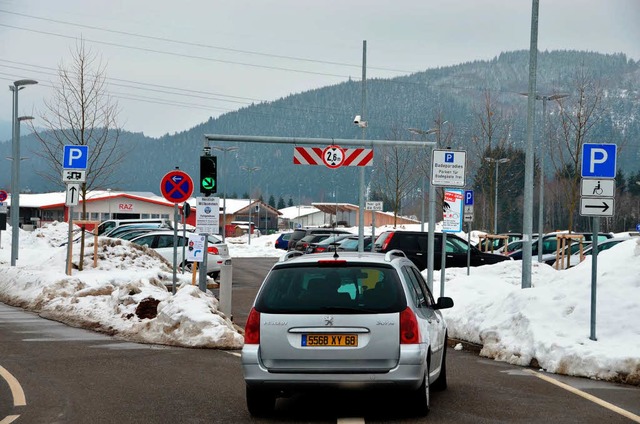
373;230;510;270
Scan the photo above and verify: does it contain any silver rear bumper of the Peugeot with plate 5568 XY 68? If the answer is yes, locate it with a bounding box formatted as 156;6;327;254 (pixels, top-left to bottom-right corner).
242;345;427;390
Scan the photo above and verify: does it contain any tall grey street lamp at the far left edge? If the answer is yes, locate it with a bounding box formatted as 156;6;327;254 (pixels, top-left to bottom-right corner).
9;79;38;266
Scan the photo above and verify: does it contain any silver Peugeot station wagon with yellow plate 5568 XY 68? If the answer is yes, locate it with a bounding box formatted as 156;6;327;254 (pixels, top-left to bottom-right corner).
242;250;453;416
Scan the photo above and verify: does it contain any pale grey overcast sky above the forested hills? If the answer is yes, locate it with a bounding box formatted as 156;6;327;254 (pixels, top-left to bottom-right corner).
0;0;640;137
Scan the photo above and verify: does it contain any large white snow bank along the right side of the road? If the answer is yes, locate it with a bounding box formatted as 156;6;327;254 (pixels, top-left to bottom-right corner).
438;238;640;385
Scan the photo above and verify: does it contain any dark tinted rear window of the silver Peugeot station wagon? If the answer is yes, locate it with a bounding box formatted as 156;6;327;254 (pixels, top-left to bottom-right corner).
256;263;407;314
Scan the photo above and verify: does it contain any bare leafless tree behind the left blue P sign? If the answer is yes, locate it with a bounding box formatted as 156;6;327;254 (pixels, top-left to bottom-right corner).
32;40;125;270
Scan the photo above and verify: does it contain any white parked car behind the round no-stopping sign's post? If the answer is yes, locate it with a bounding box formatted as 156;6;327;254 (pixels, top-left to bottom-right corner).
131;230;231;278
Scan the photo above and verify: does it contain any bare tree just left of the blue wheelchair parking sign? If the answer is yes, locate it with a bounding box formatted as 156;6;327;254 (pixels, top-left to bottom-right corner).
551;69;604;231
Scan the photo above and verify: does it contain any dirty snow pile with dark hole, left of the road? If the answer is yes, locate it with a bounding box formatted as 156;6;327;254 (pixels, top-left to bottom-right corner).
0;223;243;349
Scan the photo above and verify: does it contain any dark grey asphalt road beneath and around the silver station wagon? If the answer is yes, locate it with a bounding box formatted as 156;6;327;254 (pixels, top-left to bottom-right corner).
0;258;640;424
